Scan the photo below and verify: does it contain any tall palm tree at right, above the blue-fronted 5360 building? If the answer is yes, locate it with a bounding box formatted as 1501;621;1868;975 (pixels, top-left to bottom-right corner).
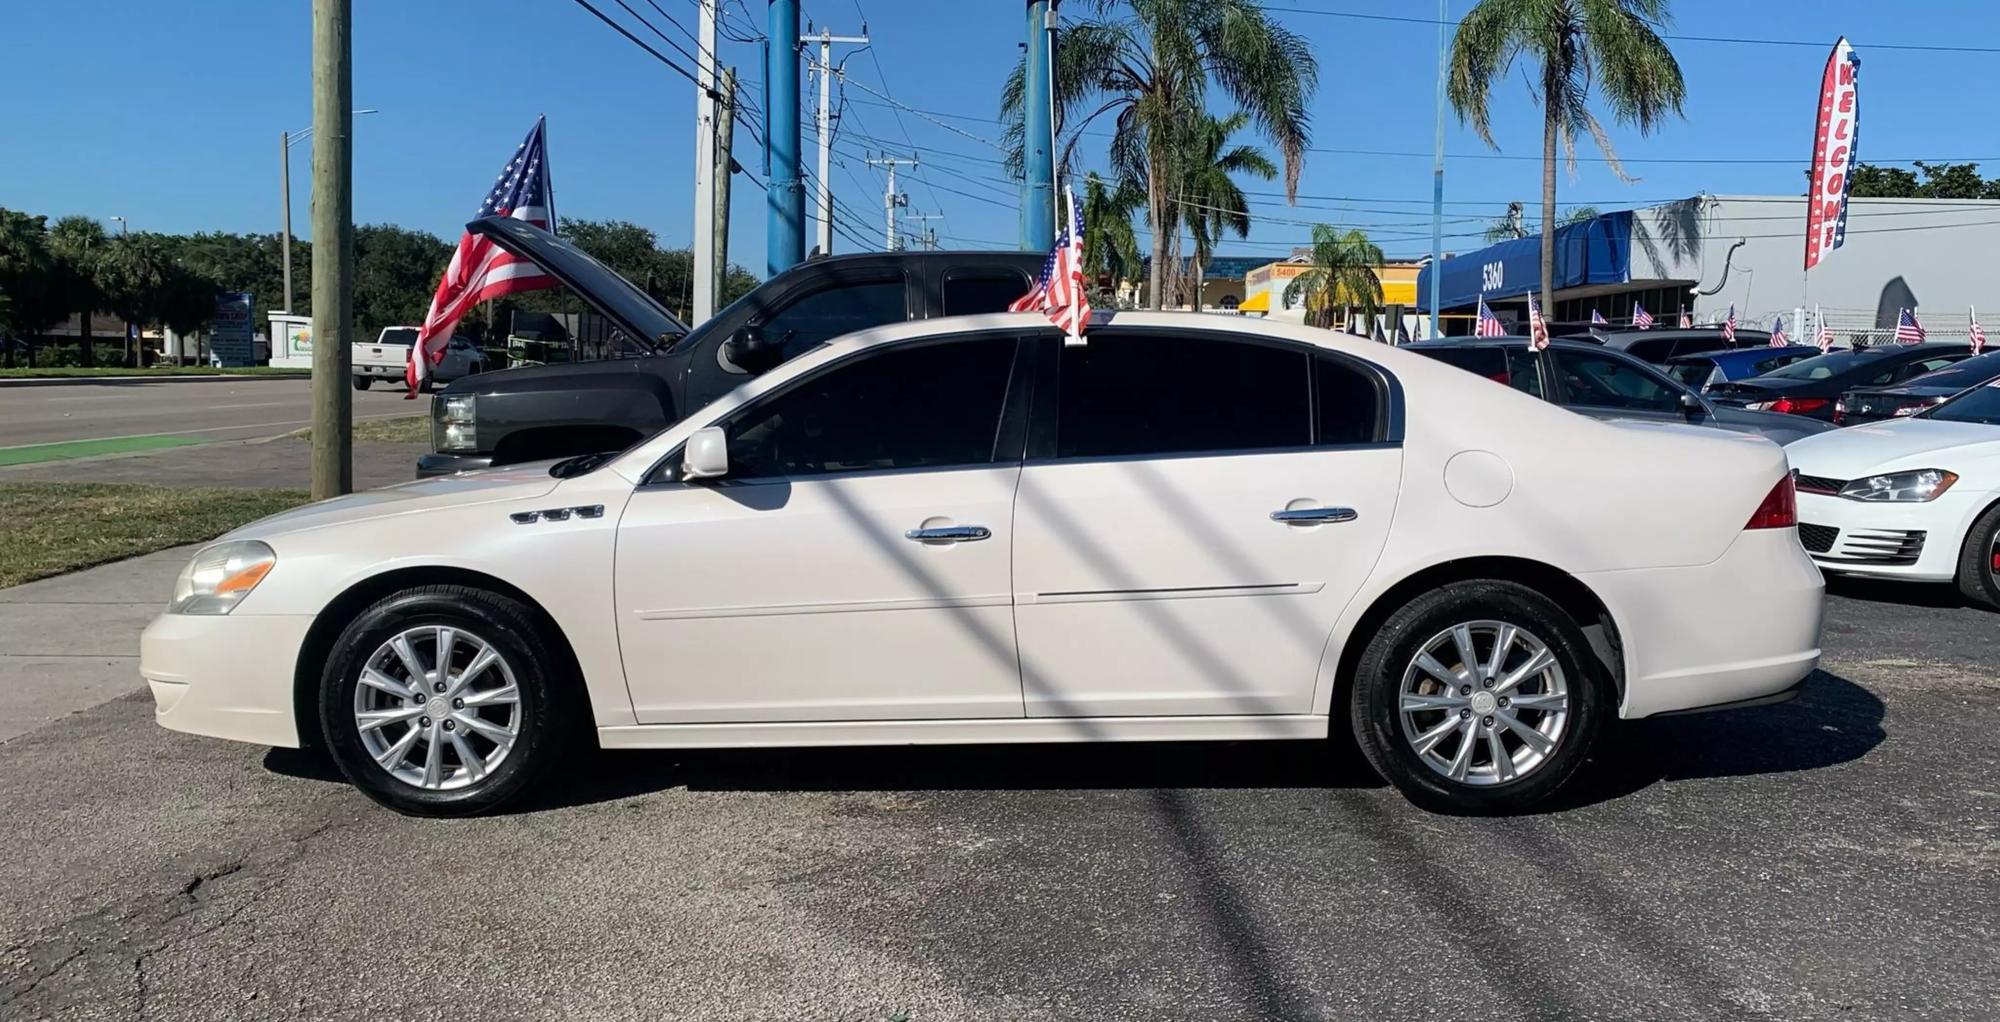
1448;0;1688;316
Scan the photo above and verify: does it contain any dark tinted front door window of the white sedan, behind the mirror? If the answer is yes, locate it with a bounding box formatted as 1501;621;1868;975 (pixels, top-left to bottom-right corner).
724;338;1014;478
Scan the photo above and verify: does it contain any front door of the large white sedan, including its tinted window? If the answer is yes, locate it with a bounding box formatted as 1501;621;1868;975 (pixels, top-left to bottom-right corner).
614;334;1026;724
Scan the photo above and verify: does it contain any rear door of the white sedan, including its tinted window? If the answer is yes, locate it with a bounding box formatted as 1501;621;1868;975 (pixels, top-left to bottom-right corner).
1014;330;1402;718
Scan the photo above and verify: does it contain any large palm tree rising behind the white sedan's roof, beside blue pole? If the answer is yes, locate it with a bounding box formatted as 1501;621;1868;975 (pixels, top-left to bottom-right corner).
1000;0;1320;308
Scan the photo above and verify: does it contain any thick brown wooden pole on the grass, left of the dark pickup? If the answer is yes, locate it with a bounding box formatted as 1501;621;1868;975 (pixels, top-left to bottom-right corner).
312;0;354;500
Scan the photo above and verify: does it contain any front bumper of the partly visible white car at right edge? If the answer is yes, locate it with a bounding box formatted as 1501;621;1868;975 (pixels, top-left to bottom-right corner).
1798;488;1994;582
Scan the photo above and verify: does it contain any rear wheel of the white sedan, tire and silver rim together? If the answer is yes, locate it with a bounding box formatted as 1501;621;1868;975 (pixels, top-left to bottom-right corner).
1352;580;1610;814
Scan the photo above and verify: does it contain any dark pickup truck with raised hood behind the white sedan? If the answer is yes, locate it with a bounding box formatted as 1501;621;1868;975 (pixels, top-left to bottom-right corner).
416;218;1044;476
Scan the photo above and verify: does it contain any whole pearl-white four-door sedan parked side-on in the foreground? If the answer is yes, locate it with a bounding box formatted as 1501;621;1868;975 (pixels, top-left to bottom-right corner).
140;314;1822;814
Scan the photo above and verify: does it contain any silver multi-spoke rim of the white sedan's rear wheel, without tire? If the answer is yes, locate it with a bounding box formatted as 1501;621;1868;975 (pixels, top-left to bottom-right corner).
1396;620;1570;786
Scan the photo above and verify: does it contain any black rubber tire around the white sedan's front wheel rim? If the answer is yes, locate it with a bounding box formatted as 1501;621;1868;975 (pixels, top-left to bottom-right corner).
320;586;590;816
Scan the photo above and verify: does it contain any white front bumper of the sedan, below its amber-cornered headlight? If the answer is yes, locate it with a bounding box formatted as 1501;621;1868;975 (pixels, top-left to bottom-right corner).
138;614;312;748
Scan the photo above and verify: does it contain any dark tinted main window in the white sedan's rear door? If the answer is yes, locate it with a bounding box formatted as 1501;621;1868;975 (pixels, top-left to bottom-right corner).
1056;334;1312;458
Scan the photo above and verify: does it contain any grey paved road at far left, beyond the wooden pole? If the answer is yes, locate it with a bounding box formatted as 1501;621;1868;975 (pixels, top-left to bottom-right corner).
0;378;430;448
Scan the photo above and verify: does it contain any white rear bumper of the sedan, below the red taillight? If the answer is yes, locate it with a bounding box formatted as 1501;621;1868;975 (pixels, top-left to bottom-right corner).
1580;528;1826;718
